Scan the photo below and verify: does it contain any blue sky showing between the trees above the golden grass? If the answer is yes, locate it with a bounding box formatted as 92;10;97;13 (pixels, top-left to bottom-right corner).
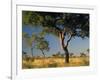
22;25;89;56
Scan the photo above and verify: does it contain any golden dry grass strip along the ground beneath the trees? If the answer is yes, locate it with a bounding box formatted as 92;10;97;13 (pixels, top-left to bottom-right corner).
22;57;89;69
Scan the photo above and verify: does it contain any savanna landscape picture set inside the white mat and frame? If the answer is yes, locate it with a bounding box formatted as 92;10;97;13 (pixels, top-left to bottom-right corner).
22;11;90;69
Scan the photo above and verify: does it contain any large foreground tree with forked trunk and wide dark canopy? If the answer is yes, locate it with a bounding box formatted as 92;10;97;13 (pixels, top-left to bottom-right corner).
22;11;89;63
